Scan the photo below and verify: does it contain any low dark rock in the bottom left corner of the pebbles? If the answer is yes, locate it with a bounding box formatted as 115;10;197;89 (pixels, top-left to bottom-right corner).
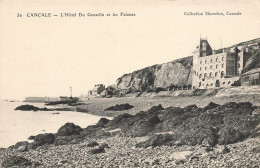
1;156;33;168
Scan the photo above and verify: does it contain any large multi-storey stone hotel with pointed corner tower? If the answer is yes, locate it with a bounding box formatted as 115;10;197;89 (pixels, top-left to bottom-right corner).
192;39;244;89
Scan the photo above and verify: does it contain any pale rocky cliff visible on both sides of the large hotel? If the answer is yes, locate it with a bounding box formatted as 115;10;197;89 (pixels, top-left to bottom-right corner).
116;38;260;92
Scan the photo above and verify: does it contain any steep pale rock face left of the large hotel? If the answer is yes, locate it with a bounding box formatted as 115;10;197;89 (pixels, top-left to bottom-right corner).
116;56;192;91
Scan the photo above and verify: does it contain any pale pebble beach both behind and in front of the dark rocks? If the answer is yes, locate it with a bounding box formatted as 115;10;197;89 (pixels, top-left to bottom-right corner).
0;95;260;168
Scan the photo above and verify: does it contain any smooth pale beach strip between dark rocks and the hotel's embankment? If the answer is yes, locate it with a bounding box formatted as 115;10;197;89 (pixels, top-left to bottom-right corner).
73;94;260;117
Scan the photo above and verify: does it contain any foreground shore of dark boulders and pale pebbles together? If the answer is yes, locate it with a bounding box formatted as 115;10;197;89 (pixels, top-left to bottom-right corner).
0;102;260;167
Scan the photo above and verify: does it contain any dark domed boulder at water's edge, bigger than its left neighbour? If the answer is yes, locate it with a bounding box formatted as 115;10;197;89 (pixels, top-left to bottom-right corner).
56;123;82;137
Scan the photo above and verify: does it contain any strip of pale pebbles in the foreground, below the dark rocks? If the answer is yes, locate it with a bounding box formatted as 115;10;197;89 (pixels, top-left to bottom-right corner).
0;136;260;168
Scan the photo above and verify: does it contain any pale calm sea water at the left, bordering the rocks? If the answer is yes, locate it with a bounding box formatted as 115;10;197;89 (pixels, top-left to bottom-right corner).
0;101;108;148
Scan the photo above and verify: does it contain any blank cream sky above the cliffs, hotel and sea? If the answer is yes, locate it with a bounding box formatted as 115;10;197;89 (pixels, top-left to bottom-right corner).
0;0;260;99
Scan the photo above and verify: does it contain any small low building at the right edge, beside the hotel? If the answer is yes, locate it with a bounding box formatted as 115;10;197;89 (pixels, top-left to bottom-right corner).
241;68;260;86
